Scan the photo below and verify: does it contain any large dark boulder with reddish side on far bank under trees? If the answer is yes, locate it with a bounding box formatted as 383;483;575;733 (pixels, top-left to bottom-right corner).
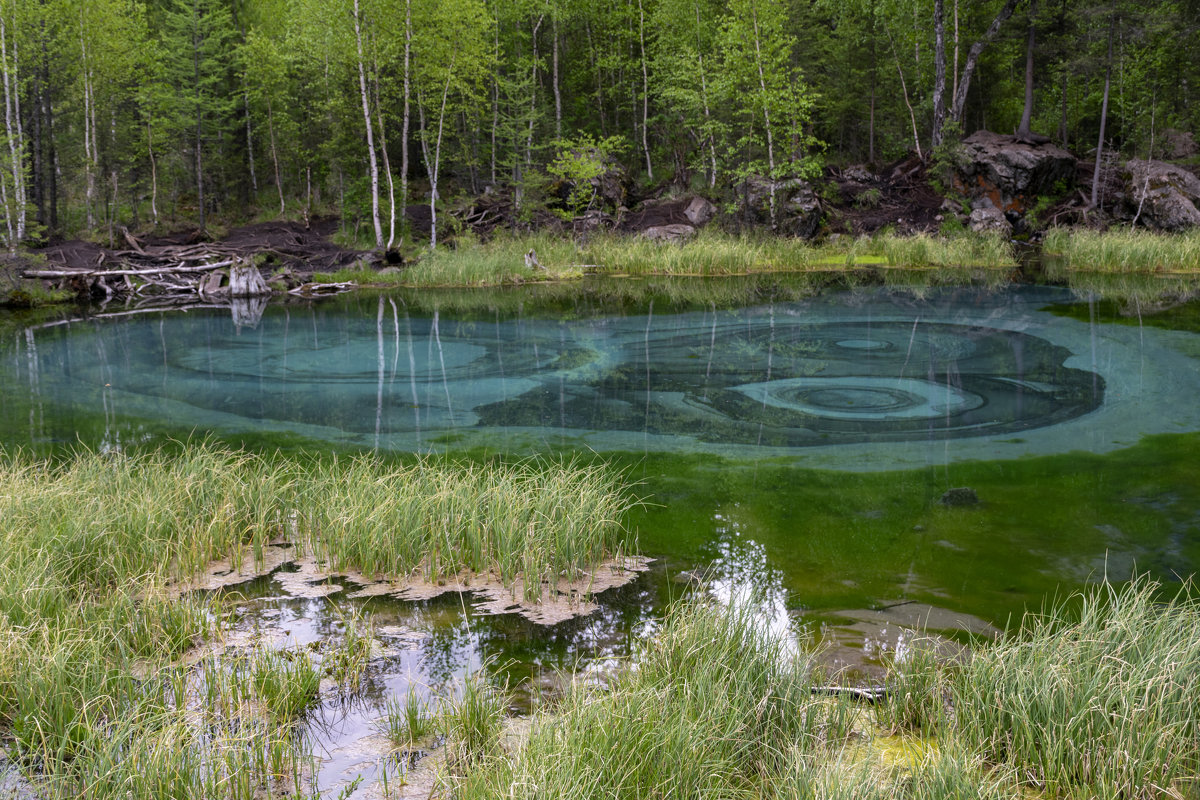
958;131;1076;212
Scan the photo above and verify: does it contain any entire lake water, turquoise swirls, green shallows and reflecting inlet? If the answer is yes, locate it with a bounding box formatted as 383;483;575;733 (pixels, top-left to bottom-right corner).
0;275;1200;786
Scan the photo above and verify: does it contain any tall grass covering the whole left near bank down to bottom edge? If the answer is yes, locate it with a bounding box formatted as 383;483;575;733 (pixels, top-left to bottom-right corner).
0;443;632;800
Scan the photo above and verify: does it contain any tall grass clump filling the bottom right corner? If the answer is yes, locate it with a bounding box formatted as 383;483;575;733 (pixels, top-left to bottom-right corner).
950;579;1200;798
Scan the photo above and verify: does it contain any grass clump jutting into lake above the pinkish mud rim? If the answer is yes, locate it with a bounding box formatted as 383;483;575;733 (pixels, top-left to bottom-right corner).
298;457;635;599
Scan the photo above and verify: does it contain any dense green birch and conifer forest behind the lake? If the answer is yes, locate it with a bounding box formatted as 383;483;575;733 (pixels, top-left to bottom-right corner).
0;0;1200;248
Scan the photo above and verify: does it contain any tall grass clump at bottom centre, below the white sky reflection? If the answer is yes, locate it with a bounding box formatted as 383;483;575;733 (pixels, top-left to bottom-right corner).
455;602;850;800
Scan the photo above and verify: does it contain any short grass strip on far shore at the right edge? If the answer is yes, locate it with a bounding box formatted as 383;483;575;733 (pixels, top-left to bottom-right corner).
1042;228;1200;273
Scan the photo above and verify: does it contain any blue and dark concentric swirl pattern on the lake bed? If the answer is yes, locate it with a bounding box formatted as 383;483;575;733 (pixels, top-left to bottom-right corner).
2;293;1105;449
